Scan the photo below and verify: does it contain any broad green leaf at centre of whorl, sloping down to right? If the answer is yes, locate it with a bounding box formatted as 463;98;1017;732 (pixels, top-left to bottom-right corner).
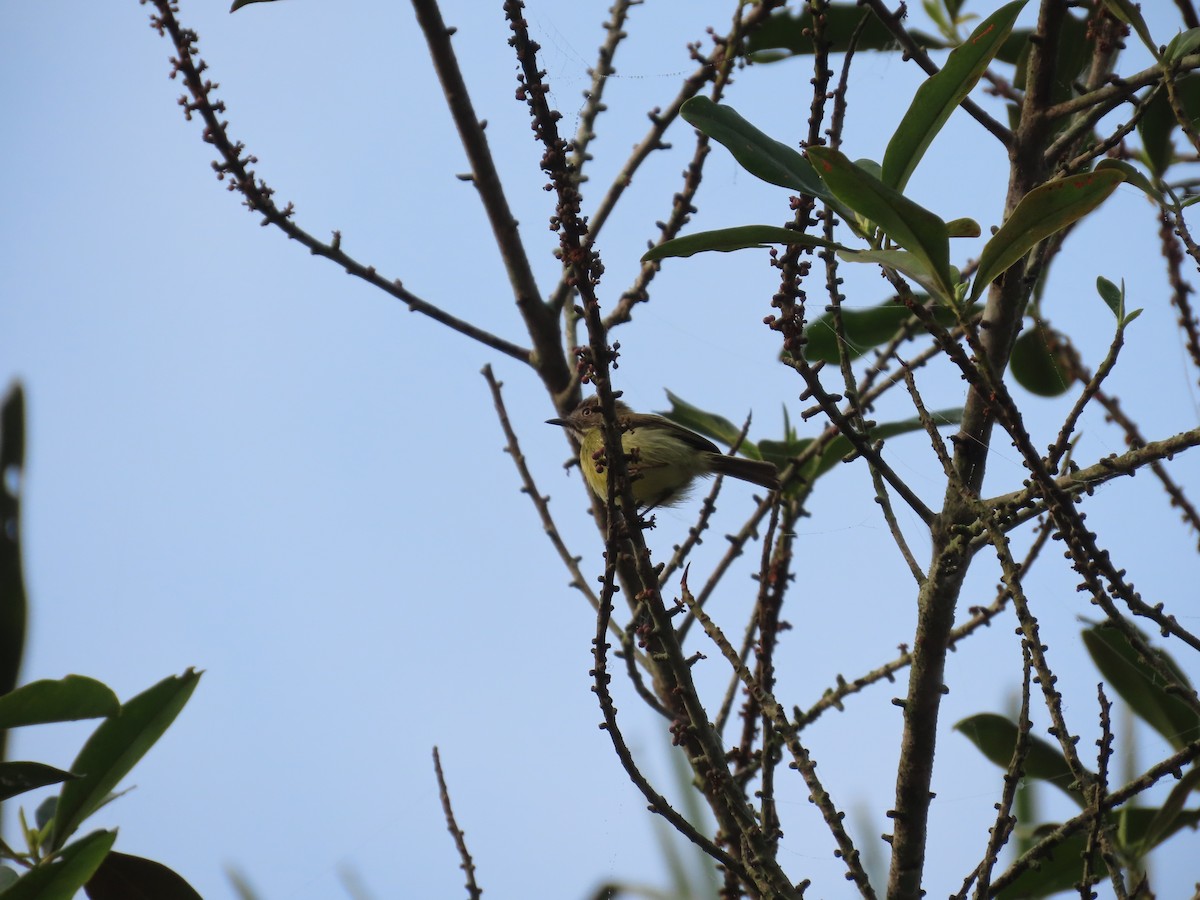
809;146;954;299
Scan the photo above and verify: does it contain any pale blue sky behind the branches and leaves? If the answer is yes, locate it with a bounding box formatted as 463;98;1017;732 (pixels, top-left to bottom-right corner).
0;0;1198;900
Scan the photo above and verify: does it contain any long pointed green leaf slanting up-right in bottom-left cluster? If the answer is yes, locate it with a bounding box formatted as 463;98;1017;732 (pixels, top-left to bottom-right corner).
50;668;200;848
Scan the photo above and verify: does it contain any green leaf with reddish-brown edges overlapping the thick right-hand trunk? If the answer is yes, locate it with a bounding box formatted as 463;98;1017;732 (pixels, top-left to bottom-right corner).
971;168;1124;301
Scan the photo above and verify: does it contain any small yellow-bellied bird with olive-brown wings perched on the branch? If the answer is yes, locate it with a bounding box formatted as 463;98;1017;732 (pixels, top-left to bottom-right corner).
546;396;780;509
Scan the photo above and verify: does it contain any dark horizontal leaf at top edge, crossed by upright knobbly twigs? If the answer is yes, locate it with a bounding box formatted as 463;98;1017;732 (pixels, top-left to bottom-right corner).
746;2;947;62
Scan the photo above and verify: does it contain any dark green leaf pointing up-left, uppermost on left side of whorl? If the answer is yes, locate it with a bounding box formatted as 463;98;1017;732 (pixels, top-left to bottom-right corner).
679;96;833;200
